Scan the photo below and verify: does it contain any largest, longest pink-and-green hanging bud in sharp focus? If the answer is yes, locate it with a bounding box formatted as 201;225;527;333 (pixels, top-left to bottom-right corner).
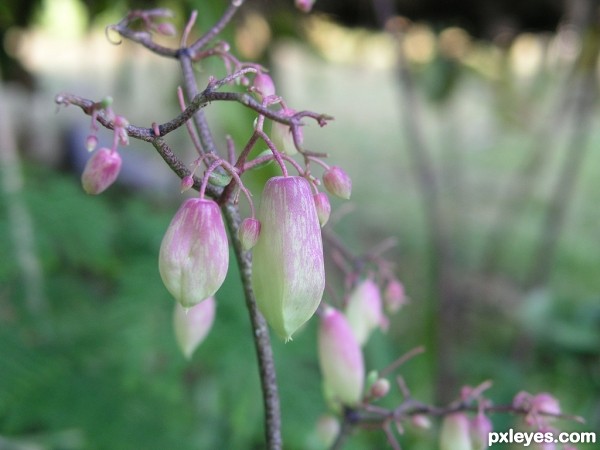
252;176;325;340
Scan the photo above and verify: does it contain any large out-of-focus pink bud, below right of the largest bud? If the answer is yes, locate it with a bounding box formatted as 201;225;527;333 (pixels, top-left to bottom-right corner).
318;307;365;406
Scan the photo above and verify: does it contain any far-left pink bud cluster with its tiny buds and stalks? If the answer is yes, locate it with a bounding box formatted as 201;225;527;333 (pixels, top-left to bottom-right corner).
81;97;129;195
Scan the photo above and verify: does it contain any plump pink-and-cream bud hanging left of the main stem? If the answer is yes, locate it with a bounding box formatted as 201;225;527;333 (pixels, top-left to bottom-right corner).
158;198;229;308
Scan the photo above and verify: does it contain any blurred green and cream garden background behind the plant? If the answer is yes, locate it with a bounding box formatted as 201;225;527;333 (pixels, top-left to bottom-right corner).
0;0;600;450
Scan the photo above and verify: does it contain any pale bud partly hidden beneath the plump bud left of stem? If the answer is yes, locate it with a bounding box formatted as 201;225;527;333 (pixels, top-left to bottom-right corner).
173;297;216;359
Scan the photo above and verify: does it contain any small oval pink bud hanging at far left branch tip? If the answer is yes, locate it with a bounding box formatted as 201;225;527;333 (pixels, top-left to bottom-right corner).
81;148;121;195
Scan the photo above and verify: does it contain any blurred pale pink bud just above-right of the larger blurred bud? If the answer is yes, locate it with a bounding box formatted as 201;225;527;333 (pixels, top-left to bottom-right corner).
344;279;387;345
